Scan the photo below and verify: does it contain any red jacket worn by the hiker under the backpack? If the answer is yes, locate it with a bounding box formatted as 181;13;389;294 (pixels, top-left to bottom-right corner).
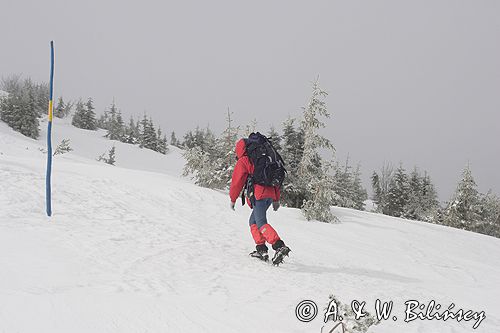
229;139;280;206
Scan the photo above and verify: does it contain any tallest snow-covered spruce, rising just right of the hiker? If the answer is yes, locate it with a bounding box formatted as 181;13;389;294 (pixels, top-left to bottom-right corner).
297;80;336;222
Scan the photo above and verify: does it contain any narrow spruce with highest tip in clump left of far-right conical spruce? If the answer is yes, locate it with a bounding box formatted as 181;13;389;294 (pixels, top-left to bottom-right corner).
387;164;410;217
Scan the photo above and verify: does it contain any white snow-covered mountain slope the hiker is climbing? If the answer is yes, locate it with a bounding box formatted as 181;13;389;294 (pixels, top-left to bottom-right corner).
0;120;500;333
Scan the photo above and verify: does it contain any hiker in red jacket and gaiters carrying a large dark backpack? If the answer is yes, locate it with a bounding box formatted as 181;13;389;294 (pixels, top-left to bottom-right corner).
229;133;290;265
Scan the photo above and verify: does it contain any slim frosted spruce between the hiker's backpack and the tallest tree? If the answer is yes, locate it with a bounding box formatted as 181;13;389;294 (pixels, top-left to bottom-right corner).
280;117;306;208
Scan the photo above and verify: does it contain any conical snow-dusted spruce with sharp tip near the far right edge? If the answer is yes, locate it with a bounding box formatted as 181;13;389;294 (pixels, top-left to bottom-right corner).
444;165;481;230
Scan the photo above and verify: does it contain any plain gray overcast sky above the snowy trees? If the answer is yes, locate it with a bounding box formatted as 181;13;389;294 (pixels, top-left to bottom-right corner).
0;0;500;200
